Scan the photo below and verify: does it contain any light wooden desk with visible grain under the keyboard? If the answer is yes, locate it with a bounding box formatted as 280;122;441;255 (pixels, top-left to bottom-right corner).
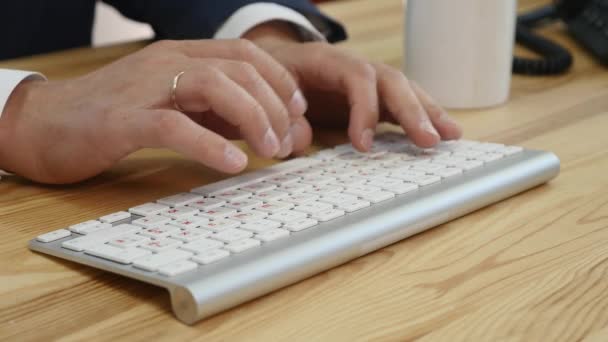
0;0;608;341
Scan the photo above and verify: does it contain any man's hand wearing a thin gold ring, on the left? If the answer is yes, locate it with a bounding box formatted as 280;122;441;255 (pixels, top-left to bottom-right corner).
0;40;307;183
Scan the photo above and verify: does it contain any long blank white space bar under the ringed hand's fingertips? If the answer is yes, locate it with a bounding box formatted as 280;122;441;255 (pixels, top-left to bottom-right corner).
190;158;320;196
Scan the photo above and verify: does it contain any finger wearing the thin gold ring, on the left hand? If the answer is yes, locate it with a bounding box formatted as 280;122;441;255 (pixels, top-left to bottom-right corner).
175;66;280;158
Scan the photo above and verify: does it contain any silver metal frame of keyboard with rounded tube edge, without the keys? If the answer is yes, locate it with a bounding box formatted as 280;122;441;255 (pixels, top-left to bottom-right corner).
29;150;560;324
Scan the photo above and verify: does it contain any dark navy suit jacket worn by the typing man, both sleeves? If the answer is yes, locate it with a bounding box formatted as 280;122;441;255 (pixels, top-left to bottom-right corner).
0;0;346;59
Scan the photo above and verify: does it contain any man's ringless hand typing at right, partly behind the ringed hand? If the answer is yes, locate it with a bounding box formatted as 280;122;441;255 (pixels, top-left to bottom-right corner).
246;22;462;152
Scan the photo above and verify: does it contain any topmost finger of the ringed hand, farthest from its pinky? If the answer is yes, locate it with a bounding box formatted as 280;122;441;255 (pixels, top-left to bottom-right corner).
172;39;308;117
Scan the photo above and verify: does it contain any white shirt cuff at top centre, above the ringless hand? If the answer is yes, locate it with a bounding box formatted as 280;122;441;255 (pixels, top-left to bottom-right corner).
214;2;326;41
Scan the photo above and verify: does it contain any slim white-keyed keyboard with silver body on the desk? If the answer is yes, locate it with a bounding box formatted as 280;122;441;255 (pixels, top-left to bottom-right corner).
30;133;559;323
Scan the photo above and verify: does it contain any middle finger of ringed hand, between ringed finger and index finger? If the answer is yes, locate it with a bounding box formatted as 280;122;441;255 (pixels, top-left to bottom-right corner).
207;59;293;158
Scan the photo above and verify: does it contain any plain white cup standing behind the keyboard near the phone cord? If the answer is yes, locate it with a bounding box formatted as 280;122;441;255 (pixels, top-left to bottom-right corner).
404;0;517;108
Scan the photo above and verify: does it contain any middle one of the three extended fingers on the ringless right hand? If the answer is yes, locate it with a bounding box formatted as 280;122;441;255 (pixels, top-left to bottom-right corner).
376;64;440;147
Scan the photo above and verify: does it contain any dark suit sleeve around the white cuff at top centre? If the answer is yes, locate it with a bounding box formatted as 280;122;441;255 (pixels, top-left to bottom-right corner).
104;0;346;42
